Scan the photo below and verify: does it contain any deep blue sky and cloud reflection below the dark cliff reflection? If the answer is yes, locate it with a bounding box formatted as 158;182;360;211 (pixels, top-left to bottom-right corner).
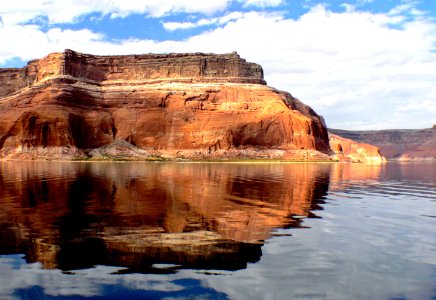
0;255;226;299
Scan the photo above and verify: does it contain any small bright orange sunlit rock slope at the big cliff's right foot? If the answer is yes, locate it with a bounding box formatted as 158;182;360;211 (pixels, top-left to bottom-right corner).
329;132;386;163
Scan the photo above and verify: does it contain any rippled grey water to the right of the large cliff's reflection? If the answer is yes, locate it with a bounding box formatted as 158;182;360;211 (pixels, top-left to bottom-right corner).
200;164;436;299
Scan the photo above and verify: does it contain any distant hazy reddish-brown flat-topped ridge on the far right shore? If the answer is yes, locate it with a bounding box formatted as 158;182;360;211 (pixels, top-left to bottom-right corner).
329;125;436;160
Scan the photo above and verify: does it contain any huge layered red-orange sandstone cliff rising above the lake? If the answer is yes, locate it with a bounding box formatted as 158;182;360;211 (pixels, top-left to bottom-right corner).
0;50;331;159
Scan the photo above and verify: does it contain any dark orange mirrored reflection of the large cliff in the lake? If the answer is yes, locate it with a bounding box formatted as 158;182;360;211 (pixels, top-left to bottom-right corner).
0;162;330;272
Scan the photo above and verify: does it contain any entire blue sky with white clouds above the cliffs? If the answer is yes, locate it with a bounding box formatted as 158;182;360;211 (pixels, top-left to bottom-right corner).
0;0;436;129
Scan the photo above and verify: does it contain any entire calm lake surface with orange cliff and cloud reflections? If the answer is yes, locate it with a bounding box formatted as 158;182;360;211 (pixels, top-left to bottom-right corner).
0;162;436;300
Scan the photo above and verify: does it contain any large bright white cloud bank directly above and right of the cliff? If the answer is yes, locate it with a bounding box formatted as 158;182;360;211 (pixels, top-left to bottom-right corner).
0;0;436;129
